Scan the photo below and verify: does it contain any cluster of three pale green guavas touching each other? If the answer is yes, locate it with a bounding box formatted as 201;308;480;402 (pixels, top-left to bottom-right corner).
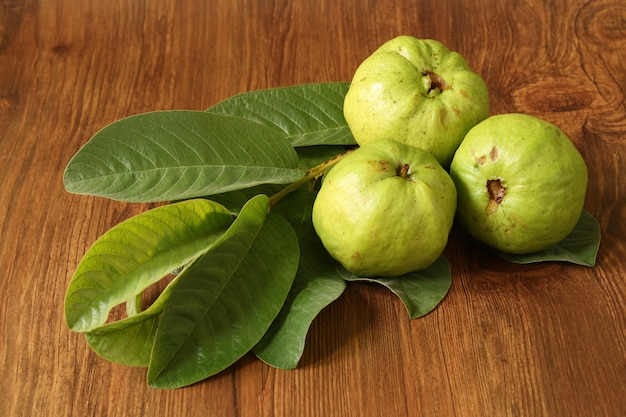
313;36;587;277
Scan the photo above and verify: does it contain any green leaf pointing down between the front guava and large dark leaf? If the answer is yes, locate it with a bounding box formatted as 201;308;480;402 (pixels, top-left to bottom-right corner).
253;188;346;369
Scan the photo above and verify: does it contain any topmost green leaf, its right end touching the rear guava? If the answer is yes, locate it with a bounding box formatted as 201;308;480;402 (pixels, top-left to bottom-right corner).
206;82;355;146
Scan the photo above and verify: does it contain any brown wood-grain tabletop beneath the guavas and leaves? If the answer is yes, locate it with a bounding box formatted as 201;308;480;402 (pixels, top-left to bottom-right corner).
0;0;626;417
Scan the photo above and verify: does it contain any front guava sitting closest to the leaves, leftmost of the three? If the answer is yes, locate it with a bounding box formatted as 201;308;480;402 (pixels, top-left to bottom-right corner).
313;139;456;277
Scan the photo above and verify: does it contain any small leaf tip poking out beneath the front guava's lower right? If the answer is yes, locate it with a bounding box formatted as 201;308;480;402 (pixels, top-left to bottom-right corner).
345;255;452;319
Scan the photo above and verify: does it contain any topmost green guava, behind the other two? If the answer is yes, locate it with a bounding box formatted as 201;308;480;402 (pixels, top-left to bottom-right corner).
344;36;489;168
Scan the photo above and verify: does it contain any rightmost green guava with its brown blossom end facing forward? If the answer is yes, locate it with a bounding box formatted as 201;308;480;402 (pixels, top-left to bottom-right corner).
450;113;588;254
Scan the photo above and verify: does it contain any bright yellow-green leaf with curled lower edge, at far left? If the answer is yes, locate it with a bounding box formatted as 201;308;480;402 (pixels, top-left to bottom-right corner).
65;200;233;332
